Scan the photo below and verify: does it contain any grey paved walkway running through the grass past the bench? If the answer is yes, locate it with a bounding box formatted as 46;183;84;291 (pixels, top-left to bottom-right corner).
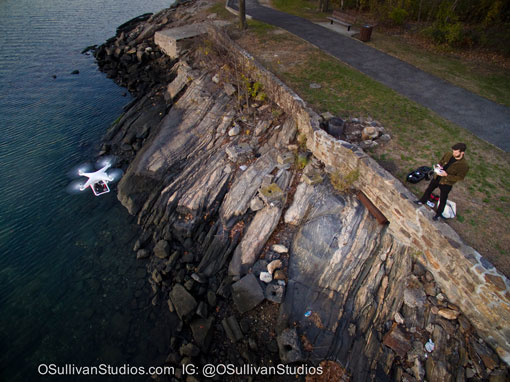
229;0;510;152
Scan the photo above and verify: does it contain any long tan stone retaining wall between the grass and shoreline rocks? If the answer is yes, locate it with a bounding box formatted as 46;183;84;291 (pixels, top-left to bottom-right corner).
209;27;510;364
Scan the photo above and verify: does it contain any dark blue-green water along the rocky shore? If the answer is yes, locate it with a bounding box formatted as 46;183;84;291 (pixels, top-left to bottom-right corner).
0;0;175;381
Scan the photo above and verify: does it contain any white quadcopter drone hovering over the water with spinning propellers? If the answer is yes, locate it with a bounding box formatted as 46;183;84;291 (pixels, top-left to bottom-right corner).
67;156;122;196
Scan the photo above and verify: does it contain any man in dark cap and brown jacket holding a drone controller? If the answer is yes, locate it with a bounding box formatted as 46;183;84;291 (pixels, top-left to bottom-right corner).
415;143;469;221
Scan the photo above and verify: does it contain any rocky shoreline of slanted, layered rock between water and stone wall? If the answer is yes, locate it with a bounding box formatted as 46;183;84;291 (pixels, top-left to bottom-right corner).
94;2;508;382
